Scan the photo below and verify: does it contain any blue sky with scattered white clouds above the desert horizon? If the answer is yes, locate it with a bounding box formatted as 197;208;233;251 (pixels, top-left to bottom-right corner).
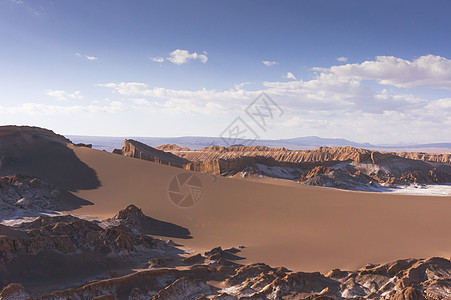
0;0;451;144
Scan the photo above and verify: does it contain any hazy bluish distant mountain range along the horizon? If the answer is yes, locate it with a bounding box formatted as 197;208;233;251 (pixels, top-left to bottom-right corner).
67;135;451;152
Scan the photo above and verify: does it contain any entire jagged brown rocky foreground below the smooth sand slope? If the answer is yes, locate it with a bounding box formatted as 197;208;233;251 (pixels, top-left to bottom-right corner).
0;206;451;300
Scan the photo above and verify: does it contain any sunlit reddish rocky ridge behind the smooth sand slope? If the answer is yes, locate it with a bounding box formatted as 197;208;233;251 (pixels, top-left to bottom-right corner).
156;145;451;190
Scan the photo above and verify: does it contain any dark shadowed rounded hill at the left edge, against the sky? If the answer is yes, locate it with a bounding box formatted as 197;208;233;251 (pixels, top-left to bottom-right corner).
0;126;100;209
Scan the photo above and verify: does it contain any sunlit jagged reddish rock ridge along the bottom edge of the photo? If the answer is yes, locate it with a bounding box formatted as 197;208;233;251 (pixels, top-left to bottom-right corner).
4;248;451;300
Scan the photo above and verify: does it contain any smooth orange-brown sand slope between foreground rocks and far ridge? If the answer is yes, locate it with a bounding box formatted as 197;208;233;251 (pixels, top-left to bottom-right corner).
70;148;451;272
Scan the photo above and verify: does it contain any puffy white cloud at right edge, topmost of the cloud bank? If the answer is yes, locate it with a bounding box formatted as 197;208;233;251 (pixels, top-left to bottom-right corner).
313;55;451;89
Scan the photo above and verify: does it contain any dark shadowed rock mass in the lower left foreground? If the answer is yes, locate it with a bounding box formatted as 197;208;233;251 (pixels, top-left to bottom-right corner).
0;207;183;299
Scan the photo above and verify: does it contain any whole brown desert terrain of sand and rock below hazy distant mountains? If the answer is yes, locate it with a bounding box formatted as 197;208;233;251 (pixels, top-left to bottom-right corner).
0;126;451;299
